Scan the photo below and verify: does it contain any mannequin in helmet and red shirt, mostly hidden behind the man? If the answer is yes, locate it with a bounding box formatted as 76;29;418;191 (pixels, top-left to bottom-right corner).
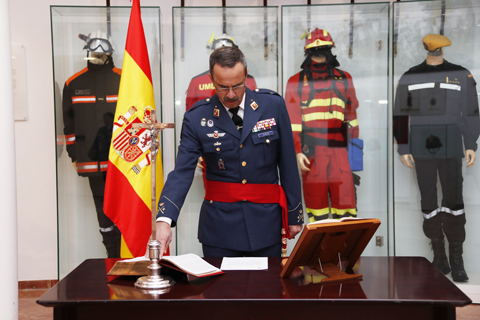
185;33;257;111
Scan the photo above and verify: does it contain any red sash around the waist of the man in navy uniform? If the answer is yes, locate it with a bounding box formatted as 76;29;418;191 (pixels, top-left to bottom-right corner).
205;179;291;239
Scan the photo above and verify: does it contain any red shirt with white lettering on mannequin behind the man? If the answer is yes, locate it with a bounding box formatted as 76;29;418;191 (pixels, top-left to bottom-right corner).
185;71;257;111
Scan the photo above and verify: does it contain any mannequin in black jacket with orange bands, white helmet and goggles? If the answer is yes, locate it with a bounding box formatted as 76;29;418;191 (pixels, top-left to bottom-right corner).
63;30;121;258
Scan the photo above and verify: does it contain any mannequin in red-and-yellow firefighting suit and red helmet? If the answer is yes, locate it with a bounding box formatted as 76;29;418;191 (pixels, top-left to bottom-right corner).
285;28;359;222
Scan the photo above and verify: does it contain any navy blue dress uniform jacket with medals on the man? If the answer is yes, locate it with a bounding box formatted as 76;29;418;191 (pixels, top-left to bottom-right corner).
157;88;303;251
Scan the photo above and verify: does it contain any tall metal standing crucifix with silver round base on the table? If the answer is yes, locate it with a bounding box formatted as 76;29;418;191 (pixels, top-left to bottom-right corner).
132;110;175;294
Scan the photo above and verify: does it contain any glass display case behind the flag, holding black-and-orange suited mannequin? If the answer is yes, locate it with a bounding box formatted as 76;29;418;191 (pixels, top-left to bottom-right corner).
51;6;161;278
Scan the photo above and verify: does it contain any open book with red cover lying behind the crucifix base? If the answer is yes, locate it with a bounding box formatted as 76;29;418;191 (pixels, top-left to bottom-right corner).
107;253;224;277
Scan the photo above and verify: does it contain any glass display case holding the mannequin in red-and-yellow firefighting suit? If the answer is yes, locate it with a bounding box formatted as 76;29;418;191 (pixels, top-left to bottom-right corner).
282;3;390;255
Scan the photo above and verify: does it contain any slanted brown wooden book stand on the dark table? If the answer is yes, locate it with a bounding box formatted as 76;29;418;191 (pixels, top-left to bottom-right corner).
280;218;380;282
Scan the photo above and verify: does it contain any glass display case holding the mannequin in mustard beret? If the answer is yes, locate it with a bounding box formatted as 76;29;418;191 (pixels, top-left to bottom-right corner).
393;0;480;296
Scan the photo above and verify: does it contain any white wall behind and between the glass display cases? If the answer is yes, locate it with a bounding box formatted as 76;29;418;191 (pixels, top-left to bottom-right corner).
11;0;390;281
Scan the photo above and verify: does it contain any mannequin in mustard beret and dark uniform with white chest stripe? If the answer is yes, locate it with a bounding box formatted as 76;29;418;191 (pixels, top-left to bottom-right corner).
394;34;480;282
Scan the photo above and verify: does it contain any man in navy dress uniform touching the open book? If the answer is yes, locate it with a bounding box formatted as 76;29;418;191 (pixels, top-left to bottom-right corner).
157;47;303;257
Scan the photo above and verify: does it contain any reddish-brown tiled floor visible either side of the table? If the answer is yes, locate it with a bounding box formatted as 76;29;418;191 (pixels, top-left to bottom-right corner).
18;289;480;320
